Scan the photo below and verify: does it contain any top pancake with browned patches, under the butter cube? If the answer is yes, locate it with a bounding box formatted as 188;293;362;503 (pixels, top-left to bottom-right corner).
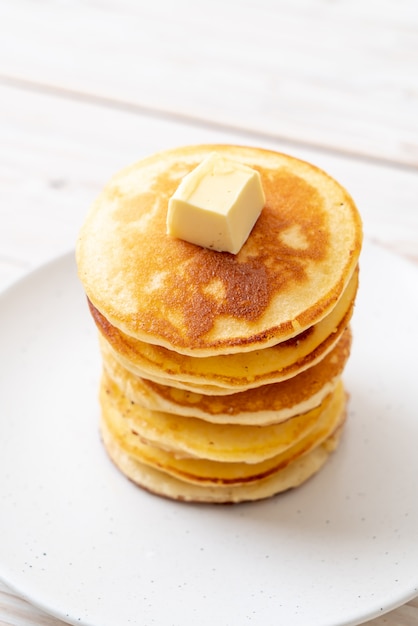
76;145;362;356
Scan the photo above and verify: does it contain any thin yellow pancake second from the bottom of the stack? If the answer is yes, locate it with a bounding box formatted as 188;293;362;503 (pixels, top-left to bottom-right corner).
102;376;345;486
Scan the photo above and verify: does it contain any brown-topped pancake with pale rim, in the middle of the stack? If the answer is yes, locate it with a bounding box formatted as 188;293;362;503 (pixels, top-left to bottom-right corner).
103;328;351;426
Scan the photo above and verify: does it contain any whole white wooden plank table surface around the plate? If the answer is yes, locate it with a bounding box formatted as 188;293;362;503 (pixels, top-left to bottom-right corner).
0;0;418;626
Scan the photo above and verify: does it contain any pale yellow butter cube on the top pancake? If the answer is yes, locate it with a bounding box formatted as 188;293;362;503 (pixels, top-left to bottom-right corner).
167;153;265;254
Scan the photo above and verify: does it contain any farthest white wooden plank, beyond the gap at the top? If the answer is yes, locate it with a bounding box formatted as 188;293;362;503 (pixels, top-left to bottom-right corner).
0;0;418;167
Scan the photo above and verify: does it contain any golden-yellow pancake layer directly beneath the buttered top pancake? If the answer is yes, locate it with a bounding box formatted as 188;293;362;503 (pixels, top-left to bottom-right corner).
90;271;358;395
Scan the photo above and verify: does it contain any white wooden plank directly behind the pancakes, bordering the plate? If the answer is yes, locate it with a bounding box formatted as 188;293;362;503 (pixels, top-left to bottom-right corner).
0;80;418;287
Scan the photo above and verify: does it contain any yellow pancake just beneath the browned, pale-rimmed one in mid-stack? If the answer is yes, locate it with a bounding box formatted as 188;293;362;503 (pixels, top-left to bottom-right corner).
100;373;341;463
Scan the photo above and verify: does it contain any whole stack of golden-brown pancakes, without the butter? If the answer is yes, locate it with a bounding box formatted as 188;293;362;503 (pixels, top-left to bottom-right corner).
76;145;362;503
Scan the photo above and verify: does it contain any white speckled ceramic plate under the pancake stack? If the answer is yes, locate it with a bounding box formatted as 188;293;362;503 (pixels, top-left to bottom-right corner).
0;244;418;626
